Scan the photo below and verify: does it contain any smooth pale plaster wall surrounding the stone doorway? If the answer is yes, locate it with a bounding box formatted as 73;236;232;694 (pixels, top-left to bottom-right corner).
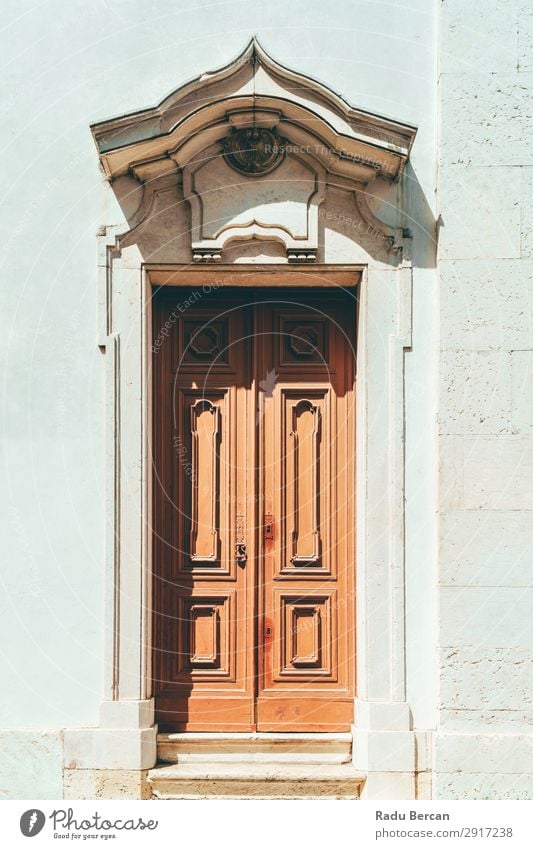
0;0;436;797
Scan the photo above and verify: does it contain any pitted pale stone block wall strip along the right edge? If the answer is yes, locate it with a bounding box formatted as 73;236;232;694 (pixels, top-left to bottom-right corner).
434;0;533;799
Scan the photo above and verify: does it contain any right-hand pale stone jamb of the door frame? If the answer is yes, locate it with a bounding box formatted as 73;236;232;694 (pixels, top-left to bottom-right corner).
353;243;418;799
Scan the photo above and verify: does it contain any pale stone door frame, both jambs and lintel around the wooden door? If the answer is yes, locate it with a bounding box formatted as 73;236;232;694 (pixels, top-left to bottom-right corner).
65;252;417;798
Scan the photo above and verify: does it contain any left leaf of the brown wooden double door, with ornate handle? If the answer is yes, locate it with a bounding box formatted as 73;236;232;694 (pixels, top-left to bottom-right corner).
154;291;255;731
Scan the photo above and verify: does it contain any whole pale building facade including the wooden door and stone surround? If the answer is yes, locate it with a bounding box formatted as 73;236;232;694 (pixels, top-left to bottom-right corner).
0;0;533;799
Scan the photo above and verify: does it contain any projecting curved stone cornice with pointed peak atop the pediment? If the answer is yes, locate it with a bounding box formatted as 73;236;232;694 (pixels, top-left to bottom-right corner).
92;38;416;182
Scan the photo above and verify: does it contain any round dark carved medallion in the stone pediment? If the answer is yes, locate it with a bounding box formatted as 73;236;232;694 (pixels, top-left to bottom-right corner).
221;127;285;176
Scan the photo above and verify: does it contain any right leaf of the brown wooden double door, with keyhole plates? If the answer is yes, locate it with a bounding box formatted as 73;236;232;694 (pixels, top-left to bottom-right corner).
256;293;355;731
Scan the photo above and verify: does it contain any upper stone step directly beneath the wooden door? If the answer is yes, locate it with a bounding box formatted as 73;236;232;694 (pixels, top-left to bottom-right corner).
157;732;352;764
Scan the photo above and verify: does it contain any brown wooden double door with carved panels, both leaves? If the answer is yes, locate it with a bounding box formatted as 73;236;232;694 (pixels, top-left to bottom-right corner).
153;287;356;731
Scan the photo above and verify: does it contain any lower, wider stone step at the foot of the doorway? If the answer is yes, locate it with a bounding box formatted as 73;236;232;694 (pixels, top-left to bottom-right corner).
148;763;364;799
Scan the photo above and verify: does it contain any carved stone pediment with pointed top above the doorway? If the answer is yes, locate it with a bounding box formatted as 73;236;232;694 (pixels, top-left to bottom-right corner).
92;39;416;262
